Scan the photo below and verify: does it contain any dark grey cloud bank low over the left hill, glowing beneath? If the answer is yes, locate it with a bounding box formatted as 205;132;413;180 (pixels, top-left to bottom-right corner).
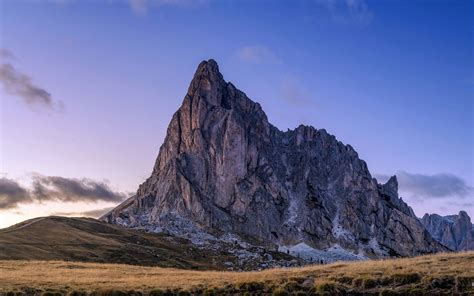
0;175;128;210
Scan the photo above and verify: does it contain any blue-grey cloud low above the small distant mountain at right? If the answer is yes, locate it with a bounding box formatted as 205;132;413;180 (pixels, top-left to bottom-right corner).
376;171;474;199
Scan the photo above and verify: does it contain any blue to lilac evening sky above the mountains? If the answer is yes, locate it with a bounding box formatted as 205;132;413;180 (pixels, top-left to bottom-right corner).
0;0;474;228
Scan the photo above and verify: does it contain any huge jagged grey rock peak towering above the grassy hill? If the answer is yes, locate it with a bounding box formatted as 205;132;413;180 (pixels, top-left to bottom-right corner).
102;60;445;257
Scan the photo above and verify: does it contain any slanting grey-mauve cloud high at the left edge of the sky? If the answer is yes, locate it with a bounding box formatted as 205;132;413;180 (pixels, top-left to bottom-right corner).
0;49;63;111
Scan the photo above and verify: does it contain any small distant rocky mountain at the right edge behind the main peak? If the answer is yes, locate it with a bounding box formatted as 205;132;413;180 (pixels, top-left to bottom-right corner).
421;211;474;251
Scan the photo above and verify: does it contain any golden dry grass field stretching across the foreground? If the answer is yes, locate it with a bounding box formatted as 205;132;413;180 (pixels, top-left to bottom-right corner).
0;252;474;295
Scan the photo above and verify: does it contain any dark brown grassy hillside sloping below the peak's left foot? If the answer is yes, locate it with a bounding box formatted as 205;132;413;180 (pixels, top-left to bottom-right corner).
0;216;299;270
